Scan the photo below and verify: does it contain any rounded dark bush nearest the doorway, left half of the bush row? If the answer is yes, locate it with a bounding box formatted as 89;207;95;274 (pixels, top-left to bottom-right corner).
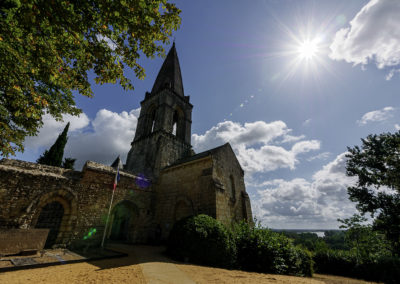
167;215;236;268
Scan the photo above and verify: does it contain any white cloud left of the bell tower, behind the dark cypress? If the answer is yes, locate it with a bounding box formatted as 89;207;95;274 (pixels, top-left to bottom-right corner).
25;109;140;170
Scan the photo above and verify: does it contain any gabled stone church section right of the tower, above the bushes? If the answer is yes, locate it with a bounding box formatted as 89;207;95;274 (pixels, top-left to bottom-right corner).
154;144;252;238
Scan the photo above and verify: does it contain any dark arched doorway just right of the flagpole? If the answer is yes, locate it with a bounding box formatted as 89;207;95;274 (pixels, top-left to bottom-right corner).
109;200;138;242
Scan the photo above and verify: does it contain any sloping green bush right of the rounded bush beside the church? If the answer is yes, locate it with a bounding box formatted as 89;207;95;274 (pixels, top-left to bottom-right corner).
233;222;312;276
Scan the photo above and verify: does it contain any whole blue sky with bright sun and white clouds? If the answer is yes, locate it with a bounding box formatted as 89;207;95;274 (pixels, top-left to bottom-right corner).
10;0;400;229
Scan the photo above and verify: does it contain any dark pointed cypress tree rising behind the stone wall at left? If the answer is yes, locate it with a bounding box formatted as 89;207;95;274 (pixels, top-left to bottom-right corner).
36;122;69;167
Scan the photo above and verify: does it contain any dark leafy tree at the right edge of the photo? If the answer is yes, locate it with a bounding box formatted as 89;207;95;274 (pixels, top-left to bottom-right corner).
346;131;400;255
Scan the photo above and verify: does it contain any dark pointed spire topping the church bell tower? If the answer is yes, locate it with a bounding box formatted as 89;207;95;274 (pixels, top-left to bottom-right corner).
151;41;184;97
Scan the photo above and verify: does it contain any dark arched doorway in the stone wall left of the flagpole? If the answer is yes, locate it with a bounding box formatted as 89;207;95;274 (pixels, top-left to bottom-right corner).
35;201;64;248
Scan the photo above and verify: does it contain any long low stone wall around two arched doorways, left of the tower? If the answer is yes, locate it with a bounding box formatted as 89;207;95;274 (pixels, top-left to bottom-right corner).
0;159;153;244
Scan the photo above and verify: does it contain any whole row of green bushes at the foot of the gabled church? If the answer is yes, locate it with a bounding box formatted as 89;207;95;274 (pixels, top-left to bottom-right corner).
167;215;312;276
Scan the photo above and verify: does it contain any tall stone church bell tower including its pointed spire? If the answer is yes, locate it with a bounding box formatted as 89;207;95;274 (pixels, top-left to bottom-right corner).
125;43;193;178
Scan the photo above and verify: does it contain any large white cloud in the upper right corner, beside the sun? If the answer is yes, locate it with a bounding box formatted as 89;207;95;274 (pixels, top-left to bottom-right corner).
329;0;400;72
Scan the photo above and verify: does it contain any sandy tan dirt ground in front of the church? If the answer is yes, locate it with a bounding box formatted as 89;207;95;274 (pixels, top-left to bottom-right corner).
0;246;378;284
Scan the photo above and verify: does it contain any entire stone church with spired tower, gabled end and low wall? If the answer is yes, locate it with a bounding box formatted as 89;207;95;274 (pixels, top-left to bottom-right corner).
0;44;252;247
